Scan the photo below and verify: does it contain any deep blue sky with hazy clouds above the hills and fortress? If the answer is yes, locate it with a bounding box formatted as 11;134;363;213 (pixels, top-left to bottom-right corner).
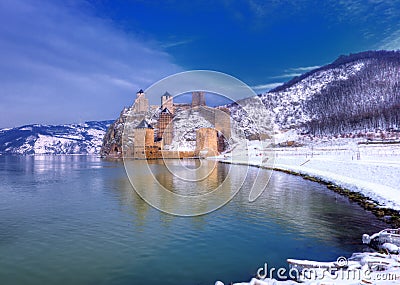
0;0;400;128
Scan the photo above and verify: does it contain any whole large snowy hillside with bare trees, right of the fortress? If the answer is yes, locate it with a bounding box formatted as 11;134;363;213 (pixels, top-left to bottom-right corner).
260;51;400;134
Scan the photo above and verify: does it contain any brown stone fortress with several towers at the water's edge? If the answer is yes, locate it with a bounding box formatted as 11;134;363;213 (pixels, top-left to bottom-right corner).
124;90;231;159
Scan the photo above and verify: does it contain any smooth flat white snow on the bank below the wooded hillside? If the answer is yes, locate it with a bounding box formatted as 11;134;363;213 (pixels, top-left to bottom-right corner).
217;140;400;210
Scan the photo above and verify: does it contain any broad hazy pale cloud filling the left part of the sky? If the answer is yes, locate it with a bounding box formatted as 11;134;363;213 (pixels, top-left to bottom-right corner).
0;0;182;127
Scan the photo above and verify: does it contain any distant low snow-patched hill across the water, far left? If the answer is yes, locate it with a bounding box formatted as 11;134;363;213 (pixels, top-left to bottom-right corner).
0;121;112;155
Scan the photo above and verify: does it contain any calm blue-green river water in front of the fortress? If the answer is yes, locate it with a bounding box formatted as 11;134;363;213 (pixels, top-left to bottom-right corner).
0;156;385;285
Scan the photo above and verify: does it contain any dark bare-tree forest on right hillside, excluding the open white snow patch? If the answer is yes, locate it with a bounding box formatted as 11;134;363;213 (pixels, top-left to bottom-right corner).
264;51;400;135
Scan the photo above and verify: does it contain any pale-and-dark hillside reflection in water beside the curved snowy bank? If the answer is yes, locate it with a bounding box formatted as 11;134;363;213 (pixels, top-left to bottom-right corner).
232;169;385;250
